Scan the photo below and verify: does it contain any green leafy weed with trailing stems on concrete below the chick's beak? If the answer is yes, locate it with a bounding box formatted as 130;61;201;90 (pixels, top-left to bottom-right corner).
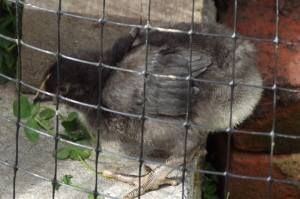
13;96;110;199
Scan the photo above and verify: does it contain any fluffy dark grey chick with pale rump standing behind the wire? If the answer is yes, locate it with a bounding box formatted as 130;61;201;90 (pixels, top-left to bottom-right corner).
34;23;262;199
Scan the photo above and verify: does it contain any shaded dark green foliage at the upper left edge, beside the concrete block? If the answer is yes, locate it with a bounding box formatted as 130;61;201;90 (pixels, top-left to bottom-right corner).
0;0;22;84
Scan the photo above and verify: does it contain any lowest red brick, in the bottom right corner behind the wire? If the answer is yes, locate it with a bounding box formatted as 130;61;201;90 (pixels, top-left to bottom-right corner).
228;148;300;199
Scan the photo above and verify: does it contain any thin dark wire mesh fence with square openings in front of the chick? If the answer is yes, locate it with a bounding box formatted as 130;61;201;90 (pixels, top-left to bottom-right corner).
0;0;300;199
